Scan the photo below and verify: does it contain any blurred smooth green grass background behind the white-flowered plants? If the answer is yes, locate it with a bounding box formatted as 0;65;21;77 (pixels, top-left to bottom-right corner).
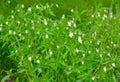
0;0;120;17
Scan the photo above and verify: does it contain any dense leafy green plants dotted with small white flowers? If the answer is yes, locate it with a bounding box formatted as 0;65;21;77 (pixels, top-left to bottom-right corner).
0;0;120;82
